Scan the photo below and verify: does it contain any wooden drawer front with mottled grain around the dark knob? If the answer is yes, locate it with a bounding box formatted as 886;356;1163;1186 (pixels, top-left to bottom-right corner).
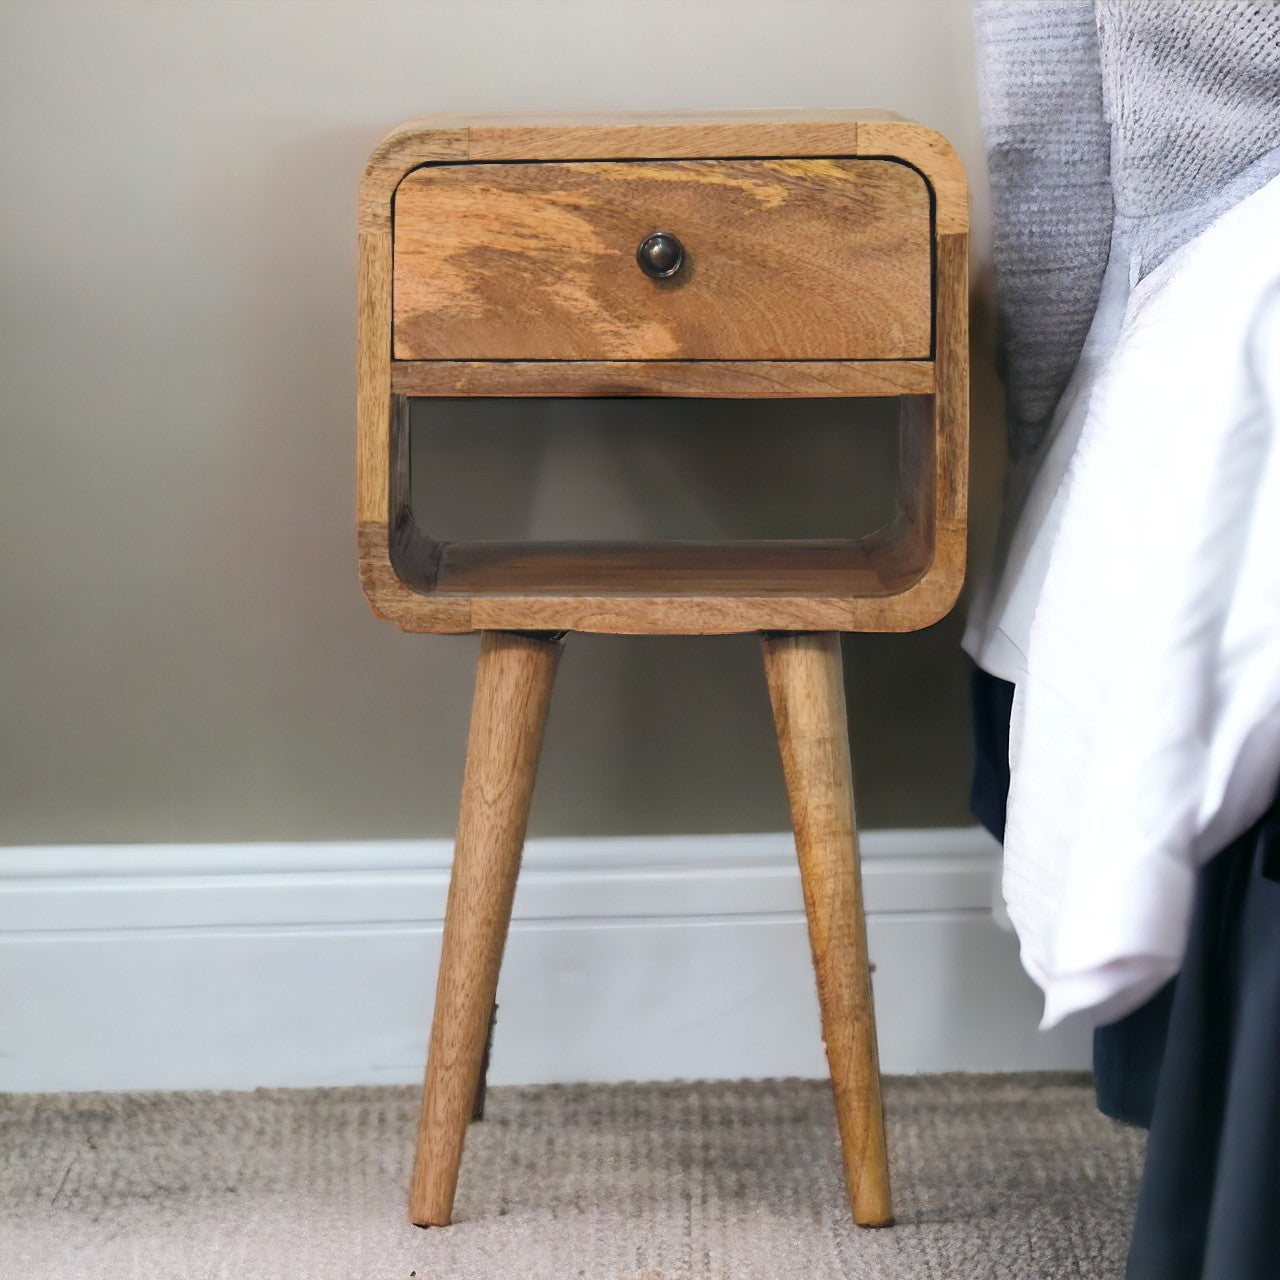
393;159;932;360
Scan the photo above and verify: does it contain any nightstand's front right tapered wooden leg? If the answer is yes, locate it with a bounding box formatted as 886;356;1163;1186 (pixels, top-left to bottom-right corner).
764;634;893;1226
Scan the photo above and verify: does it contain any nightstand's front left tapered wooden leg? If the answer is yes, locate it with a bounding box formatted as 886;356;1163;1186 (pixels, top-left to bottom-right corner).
410;631;561;1226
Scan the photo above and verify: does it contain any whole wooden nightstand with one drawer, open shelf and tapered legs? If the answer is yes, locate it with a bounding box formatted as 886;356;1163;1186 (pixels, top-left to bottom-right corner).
357;111;969;1226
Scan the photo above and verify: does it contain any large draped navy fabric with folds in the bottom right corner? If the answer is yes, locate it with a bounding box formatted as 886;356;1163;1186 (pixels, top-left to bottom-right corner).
1125;795;1280;1280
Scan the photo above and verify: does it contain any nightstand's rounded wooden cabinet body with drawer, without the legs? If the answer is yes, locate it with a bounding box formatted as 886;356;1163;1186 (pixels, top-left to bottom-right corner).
357;111;969;635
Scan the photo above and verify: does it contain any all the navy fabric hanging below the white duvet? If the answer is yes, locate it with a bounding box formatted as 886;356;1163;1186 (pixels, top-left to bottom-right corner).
972;668;1280;1280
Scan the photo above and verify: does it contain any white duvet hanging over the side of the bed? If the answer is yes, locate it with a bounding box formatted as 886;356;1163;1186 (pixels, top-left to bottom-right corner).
966;172;1280;1027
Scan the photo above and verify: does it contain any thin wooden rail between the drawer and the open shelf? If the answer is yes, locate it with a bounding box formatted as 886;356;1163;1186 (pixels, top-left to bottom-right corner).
392;360;933;399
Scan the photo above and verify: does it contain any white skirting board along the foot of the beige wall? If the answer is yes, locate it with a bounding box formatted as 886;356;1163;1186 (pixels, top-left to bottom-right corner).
0;828;1089;1092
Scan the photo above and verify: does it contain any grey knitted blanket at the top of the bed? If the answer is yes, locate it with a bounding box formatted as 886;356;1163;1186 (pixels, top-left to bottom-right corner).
974;0;1280;466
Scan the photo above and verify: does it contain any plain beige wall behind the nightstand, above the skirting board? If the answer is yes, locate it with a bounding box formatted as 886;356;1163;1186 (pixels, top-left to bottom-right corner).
0;0;1000;844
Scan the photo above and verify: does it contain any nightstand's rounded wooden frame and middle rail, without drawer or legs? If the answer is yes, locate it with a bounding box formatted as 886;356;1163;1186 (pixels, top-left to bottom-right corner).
357;111;968;634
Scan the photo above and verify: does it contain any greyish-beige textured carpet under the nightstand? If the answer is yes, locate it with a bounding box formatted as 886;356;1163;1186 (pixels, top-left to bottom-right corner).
0;1075;1144;1280
